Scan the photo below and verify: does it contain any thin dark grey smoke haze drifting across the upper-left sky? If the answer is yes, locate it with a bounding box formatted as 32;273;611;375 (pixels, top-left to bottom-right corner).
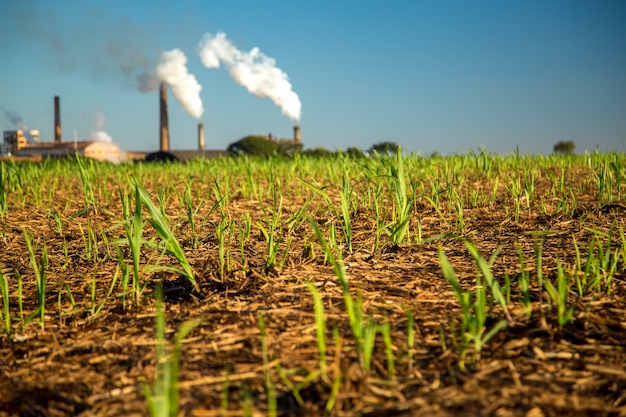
0;0;159;88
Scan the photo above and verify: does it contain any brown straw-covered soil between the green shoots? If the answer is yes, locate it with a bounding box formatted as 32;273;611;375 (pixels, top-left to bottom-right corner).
0;158;626;417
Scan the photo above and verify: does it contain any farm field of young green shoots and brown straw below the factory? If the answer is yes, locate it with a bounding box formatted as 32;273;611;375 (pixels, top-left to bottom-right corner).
0;150;626;417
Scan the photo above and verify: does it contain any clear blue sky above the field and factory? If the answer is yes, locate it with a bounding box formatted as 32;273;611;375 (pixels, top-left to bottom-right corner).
0;0;626;154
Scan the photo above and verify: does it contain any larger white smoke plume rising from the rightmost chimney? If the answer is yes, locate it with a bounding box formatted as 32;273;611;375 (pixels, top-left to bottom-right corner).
198;32;302;123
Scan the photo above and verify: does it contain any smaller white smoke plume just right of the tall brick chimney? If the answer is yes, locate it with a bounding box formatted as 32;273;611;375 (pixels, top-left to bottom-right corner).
154;48;204;120
